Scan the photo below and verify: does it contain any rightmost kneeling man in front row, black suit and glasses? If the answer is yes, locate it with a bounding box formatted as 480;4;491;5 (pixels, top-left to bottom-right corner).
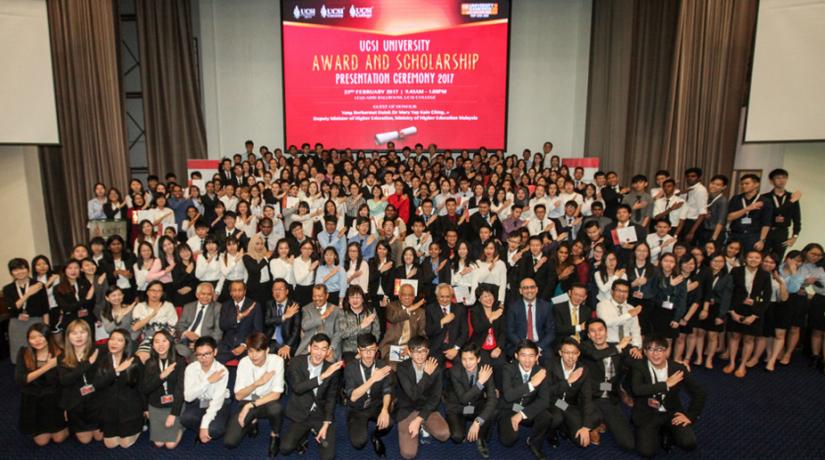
631;335;705;458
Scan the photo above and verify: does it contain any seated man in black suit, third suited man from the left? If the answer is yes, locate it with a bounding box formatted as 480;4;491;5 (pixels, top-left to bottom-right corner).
264;278;301;360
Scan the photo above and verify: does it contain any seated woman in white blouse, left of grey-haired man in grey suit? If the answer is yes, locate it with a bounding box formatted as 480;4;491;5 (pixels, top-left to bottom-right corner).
132;281;178;363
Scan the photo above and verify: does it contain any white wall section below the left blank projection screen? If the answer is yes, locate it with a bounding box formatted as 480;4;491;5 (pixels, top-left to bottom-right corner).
0;145;51;285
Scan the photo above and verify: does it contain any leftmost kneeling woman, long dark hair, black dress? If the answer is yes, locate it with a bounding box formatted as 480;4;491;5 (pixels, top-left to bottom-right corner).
15;323;69;446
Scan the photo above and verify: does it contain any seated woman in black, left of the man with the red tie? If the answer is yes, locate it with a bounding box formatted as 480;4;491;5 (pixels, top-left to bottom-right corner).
469;286;507;375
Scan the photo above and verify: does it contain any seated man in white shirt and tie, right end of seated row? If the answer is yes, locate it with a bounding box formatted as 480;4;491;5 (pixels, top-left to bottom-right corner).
596;279;642;350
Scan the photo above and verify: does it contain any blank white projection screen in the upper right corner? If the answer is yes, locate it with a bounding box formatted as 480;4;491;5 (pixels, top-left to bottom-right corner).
745;0;825;142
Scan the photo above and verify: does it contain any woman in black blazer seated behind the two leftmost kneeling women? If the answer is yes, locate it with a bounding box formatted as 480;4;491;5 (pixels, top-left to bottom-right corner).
54;260;95;334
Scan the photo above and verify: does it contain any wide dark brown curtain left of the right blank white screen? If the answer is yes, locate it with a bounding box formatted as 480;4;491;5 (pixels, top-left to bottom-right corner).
585;0;756;178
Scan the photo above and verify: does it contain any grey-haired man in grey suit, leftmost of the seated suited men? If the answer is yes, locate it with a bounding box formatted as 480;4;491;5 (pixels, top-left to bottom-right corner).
175;283;223;358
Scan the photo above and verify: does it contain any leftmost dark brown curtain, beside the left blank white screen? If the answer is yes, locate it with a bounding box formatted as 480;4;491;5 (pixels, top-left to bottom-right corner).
40;0;129;263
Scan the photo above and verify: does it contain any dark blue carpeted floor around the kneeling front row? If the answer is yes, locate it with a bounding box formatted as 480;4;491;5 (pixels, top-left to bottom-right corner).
0;358;825;460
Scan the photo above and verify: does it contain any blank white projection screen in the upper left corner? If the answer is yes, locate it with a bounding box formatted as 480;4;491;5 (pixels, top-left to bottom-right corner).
0;0;60;144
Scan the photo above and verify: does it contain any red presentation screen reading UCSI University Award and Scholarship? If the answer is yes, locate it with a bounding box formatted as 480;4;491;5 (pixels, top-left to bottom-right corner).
281;0;510;150
